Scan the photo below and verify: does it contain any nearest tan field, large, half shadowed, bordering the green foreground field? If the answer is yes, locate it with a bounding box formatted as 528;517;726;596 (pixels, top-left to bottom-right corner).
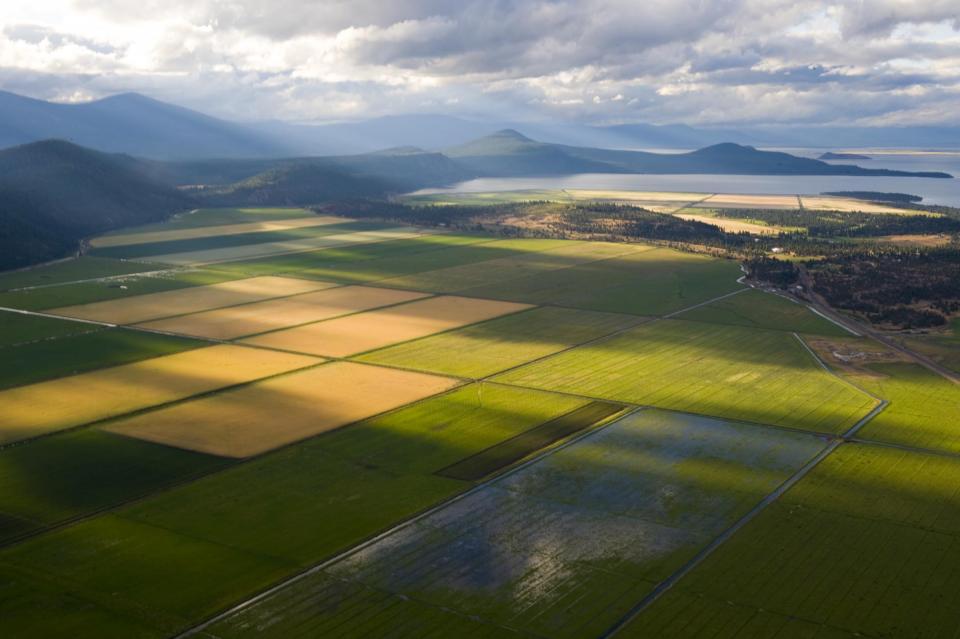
105;362;457;457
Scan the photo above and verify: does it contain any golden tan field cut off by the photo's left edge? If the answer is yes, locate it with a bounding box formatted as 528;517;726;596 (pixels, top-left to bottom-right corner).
0;345;323;443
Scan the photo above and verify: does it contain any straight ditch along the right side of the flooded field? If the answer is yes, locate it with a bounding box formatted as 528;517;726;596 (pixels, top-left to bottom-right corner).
598;400;889;639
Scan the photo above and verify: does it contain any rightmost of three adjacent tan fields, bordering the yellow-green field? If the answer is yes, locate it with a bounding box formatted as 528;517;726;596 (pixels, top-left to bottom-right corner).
244;296;531;357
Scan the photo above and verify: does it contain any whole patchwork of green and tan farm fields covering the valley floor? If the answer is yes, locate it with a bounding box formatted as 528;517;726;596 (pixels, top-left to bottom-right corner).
0;206;960;639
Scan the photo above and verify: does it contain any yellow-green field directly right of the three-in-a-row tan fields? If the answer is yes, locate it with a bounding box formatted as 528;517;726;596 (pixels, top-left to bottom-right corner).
359;307;646;378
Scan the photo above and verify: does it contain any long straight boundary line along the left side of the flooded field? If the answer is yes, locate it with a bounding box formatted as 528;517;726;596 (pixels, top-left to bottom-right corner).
172;406;644;639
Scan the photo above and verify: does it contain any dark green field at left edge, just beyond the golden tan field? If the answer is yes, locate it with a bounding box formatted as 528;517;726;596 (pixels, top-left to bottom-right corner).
0;324;204;389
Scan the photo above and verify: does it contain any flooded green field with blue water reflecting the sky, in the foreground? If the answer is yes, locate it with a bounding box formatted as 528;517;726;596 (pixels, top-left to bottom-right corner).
207;410;825;639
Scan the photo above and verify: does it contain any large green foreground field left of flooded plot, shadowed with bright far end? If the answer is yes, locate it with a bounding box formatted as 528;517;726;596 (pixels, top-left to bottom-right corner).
0;385;585;639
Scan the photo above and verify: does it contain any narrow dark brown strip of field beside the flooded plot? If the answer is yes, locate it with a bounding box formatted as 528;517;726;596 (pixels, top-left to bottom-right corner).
437;402;624;481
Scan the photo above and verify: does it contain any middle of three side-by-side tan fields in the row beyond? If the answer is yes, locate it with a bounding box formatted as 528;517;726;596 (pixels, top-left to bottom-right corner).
138;286;428;339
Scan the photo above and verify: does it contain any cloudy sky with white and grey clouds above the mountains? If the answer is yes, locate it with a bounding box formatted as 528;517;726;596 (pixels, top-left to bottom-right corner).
0;0;960;126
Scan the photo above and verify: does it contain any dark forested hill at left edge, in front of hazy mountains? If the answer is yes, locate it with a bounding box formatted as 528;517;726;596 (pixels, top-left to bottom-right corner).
0;140;192;269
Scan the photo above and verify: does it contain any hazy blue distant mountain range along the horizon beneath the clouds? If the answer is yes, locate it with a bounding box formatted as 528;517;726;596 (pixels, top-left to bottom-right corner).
0;91;960;160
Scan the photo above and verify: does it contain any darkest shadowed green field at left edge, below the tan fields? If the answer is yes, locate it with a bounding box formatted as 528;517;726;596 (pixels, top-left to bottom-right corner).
0;429;227;543
